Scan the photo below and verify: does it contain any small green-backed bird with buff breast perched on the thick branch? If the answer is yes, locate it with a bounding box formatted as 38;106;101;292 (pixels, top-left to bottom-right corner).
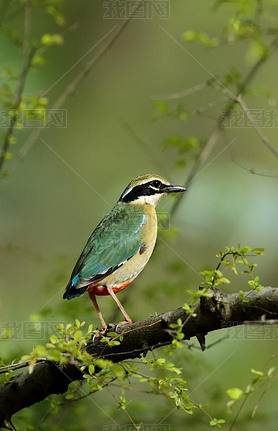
63;174;186;331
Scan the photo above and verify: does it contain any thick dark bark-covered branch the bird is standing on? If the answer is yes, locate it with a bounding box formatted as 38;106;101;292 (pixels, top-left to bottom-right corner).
0;287;278;426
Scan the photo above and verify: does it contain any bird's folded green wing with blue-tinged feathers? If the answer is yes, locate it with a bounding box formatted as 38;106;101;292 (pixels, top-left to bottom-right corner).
66;203;146;296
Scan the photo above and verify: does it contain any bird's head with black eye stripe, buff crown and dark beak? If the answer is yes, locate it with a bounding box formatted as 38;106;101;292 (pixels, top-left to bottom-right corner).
120;175;186;206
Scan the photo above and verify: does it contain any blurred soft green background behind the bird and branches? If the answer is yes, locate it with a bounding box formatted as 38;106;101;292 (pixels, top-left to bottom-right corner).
0;0;278;430
